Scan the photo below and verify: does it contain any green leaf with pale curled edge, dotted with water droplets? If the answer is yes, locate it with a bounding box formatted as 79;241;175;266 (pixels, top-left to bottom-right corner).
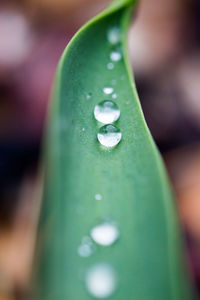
33;0;195;300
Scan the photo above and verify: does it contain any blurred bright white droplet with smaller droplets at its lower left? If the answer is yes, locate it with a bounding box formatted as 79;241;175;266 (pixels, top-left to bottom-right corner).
90;222;119;246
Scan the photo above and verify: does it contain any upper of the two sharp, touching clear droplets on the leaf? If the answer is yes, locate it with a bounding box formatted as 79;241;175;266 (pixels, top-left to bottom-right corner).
94;100;120;124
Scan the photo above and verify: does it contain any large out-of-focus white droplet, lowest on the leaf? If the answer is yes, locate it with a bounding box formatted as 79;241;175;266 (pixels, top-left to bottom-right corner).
86;264;116;299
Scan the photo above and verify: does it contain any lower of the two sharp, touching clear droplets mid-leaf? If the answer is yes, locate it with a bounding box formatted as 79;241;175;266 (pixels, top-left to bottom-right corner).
97;124;122;148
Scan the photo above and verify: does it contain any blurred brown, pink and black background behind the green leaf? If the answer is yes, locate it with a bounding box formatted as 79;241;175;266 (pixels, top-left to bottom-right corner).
0;0;200;300
